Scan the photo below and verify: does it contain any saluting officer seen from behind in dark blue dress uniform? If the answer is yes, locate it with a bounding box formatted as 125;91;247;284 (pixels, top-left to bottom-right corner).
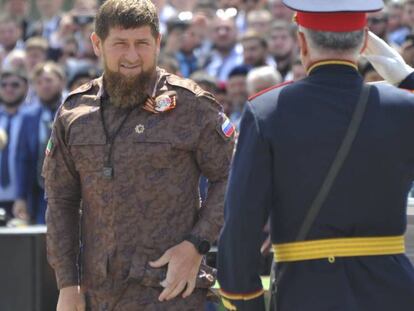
218;0;414;311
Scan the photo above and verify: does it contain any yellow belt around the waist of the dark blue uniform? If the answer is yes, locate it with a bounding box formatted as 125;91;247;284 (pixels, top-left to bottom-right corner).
273;235;405;263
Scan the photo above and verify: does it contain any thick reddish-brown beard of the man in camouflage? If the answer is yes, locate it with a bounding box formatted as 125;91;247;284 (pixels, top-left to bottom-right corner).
104;64;155;108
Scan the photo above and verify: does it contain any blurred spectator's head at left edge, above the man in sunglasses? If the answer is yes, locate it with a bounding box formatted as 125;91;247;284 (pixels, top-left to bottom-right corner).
0;15;24;55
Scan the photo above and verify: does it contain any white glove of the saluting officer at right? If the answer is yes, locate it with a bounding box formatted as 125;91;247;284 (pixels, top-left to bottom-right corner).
362;31;414;85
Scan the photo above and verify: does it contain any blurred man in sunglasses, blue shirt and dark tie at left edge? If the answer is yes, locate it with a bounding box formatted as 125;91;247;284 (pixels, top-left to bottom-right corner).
0;69;28;219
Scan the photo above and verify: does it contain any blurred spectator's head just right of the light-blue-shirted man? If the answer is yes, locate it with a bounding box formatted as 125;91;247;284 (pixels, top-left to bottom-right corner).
240;30;276;67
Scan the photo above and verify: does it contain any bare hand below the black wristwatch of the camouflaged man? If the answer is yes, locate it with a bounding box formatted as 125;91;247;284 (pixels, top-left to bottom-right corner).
149;241;203;301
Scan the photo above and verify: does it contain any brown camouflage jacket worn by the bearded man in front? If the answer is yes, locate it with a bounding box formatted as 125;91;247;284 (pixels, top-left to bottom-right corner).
43;69;234;288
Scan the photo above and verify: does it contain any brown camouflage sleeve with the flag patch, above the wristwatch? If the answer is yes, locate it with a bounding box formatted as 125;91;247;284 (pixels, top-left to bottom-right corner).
191;94;235;243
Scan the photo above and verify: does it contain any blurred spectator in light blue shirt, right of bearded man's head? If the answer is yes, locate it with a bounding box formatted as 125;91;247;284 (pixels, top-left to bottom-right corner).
204;16;243;81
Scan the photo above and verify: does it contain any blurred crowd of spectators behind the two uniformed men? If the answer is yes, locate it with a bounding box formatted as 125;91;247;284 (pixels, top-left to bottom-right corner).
0;0;414;224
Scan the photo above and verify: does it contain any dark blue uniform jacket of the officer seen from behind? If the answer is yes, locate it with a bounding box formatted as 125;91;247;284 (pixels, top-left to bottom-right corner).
218;63;414;311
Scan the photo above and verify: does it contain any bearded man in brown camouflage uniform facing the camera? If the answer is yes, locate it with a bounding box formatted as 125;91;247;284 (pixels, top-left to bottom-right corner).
43;0;234;311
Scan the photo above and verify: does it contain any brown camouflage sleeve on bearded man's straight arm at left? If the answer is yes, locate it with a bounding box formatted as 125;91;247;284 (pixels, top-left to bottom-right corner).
43;107;81;289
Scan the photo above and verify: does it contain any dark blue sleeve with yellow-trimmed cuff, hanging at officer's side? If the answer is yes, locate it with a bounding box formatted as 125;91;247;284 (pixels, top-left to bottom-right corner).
218;103;272;311
